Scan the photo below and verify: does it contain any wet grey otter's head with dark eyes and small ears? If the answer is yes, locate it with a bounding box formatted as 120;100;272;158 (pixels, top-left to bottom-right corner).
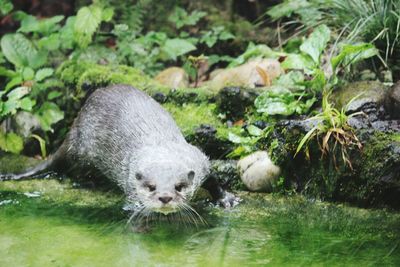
134;165;196;214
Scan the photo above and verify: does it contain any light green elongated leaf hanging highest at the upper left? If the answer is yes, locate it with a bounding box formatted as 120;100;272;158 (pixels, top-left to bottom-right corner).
74;5;102;47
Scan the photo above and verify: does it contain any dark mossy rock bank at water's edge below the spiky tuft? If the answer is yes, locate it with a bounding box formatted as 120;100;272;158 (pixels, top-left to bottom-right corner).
264;123;400;208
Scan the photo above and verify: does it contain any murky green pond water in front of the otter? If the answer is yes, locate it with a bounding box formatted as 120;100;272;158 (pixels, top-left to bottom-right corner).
0;157;400;267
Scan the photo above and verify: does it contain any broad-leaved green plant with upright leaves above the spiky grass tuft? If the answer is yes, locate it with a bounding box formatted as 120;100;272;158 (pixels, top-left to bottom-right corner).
255;24;376;116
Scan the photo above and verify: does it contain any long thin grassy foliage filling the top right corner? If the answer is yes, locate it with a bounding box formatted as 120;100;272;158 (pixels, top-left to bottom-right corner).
267;0;400;63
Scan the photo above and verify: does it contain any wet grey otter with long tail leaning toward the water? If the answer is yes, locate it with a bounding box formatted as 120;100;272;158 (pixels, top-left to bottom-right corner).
3;85;231;218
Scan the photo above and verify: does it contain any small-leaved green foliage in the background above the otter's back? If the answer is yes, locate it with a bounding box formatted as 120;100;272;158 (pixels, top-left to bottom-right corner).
112;5;234;75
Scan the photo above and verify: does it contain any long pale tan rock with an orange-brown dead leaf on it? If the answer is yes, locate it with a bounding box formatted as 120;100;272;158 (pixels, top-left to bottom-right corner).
210;59;283;91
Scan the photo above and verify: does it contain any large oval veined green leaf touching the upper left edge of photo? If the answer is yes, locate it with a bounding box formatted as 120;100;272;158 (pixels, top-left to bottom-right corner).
0;33;47;69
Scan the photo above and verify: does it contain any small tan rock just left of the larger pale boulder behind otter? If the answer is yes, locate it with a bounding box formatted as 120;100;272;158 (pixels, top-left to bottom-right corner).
155;67;189;88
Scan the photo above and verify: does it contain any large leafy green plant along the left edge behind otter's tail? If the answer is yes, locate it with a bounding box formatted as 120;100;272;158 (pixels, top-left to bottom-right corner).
0;4;112;155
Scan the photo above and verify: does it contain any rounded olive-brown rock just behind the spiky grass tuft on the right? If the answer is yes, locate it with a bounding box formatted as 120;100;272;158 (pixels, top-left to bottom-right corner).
332;81;388;122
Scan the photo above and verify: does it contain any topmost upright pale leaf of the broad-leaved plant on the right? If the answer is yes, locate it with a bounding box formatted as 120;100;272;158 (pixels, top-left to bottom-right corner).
300;24;331;64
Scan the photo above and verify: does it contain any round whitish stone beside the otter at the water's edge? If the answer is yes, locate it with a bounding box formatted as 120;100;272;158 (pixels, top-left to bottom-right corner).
237;151;281;192
